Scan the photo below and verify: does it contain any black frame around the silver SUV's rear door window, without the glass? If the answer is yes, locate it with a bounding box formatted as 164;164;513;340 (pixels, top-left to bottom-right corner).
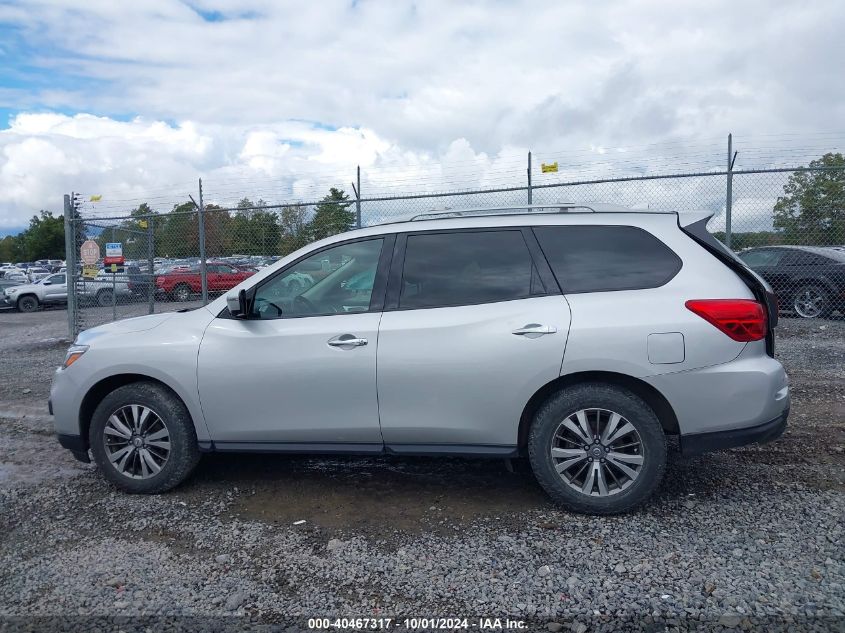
384;225;562;312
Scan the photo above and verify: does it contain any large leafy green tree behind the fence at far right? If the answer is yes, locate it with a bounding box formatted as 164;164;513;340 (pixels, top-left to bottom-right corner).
774;153;845;245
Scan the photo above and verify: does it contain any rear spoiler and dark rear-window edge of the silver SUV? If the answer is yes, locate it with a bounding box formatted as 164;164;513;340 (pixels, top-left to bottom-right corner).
678;211;778;357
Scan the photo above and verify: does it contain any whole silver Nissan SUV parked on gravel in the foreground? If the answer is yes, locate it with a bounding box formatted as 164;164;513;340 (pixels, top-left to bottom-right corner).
51;204;789;514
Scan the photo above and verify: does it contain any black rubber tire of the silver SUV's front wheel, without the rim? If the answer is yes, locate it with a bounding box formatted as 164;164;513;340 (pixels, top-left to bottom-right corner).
88;381;200;494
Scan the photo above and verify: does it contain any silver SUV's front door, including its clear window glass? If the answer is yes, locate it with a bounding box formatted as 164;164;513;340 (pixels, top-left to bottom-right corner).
198;238;386;452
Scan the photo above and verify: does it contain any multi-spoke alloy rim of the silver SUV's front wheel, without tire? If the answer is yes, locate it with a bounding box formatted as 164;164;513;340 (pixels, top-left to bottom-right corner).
103;404;170;479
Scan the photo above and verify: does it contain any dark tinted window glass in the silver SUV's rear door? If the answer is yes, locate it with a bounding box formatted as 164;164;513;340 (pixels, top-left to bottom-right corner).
399;230;544;309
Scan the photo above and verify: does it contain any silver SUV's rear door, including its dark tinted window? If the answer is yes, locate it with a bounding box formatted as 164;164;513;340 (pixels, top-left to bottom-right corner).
378;228;569;454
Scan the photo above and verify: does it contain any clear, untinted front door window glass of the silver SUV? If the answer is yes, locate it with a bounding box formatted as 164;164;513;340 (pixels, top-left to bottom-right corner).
251;238;384;319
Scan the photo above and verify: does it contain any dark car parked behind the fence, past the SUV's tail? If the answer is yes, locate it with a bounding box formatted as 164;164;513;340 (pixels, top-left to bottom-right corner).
739;246;845;319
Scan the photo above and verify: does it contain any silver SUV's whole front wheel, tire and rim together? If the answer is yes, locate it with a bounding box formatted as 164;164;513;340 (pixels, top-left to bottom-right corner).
88;382;200;494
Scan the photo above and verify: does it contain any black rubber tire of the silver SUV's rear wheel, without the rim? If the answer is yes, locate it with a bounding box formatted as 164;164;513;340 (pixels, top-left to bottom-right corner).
528;383;666;515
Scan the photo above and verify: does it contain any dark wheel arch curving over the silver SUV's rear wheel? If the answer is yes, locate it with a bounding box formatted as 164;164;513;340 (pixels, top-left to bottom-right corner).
517;371;680;451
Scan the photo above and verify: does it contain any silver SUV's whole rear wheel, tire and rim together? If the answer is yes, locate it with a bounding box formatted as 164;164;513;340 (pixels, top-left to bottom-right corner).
528;383;666;514
